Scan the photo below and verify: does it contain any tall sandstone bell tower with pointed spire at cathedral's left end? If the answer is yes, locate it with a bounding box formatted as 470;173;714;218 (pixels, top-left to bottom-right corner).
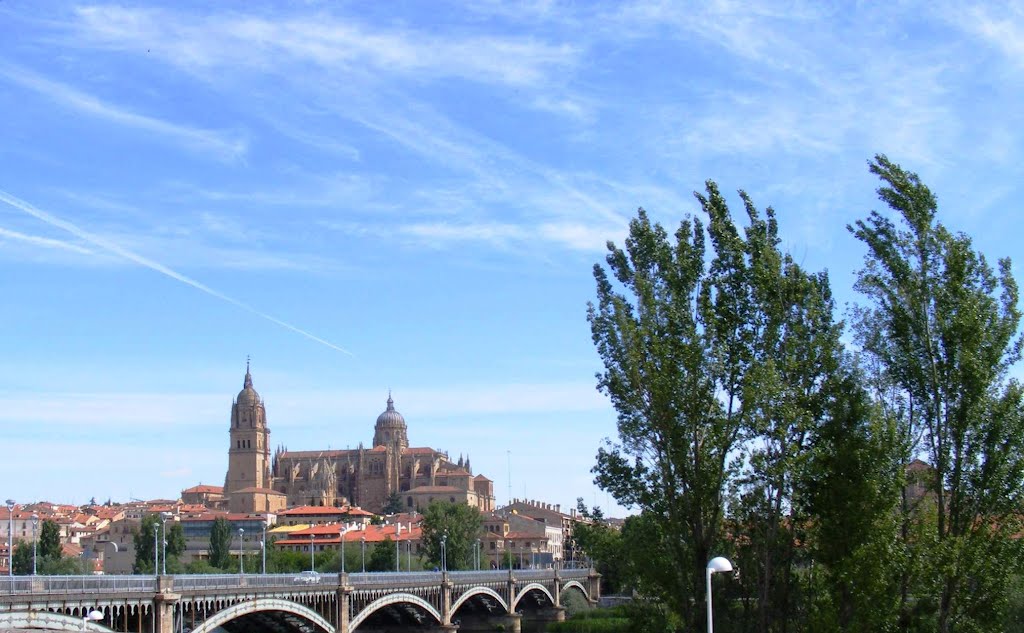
224;360;270;495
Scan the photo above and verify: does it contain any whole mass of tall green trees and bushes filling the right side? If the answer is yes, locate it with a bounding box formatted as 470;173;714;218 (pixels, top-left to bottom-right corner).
575;156;1024;633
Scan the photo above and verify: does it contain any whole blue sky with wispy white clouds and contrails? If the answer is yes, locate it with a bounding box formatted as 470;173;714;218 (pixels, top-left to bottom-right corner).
0;0;1024;506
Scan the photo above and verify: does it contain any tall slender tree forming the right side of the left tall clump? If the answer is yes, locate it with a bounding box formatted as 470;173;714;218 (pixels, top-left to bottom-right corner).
705;193;842;632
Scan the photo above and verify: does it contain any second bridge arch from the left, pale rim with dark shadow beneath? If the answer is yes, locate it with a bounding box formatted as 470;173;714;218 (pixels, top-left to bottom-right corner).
193;598;336;633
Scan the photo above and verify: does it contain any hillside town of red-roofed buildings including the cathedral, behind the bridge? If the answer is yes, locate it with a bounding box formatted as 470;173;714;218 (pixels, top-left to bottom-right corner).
0;363;598;575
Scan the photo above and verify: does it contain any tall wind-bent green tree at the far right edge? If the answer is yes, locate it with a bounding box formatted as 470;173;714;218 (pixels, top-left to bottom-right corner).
850;156;1024;633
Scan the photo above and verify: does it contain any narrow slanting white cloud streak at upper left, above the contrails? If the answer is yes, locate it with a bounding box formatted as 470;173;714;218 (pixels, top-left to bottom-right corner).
0;64;246;160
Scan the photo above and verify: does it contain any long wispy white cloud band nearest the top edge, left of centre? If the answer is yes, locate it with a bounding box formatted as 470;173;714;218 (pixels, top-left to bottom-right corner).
71;6;580;86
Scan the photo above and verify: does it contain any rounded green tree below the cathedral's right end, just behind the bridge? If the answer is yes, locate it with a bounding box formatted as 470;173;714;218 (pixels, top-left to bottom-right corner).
420;501;483;569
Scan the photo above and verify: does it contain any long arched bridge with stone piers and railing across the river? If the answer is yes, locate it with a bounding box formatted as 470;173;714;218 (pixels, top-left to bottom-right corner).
0;569;600;633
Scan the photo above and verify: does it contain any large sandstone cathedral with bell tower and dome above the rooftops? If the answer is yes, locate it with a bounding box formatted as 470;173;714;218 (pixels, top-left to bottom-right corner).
224;363;495;513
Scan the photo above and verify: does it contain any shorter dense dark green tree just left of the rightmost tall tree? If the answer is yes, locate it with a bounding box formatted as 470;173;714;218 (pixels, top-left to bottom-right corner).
800;365;902;633
